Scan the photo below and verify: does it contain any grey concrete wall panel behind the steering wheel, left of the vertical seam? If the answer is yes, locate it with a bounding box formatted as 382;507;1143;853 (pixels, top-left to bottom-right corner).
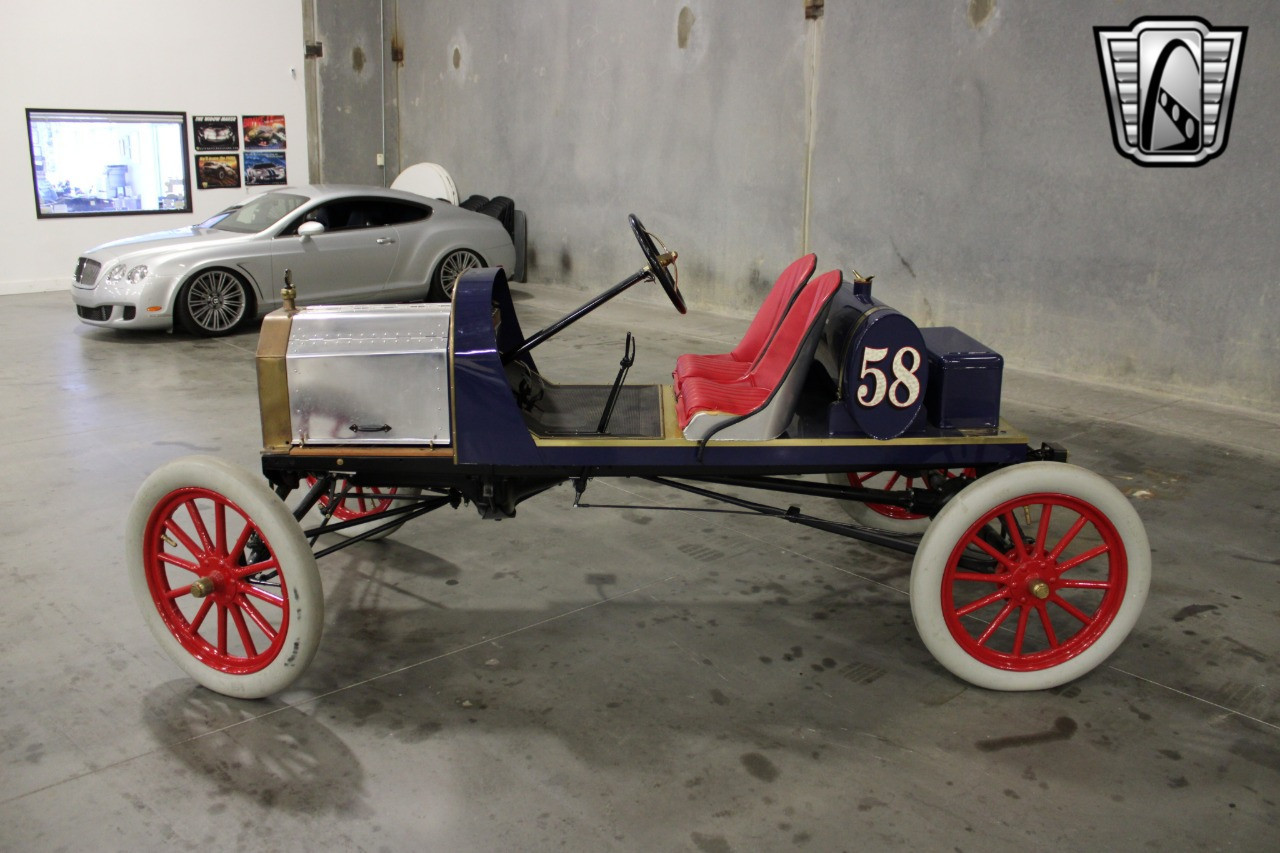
398;0;806;307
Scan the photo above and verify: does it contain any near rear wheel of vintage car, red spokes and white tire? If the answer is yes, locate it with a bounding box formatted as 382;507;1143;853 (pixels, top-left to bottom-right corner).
911;462;1151;690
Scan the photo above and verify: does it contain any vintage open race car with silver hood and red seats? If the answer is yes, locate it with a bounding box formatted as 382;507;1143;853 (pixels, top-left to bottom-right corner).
125;216;1151;697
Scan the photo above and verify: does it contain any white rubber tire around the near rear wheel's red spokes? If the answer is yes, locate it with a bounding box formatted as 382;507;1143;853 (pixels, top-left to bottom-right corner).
910;462;1151;690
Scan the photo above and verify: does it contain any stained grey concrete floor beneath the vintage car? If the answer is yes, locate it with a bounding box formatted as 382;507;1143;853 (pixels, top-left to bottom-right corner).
0;286;1280;853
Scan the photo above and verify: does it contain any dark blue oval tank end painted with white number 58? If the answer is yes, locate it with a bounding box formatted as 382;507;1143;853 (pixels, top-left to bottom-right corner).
840;305;929;439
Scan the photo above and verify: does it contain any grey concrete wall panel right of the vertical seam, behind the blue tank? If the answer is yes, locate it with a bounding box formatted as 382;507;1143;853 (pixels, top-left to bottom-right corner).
813;0;1280;411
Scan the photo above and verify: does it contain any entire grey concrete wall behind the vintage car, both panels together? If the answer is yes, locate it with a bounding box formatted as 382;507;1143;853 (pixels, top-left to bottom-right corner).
290;0;1280;411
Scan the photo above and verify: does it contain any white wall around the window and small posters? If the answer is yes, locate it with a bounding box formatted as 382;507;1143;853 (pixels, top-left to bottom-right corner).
0;0;308;297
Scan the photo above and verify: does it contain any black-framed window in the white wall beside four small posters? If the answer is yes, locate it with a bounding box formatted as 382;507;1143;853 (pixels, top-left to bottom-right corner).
27;109;192;219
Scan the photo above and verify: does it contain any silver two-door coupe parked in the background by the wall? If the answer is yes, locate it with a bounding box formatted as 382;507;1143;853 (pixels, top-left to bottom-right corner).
72;186;524;336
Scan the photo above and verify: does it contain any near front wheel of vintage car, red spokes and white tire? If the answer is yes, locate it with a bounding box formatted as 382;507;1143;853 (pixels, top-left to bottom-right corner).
125;457;324;698
